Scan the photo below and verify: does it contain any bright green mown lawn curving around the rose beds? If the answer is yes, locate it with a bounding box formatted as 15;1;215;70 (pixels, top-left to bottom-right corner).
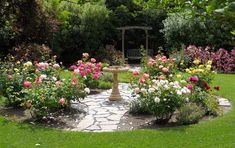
0;74;235;148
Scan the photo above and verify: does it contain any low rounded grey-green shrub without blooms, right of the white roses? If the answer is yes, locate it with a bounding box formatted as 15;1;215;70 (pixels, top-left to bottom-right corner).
176;103;204;125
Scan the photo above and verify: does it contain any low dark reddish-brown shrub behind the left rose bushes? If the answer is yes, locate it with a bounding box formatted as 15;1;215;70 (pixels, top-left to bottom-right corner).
10;43;52;61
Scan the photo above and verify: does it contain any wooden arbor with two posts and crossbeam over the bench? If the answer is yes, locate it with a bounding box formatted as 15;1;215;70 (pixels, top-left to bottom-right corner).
117;26;152;59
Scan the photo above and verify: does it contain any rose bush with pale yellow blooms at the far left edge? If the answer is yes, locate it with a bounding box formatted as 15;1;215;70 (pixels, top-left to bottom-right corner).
0;56;35;107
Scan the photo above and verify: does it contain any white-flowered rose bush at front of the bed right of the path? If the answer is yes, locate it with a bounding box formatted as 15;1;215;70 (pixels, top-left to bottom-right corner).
130;79;191;123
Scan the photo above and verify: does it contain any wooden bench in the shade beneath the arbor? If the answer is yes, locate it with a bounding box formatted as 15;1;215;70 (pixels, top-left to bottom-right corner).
126;49;153;60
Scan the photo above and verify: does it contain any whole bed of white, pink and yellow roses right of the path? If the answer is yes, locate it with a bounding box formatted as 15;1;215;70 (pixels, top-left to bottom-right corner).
130;55;219;124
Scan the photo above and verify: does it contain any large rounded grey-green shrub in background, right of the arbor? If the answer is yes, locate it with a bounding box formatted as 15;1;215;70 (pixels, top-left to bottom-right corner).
162;12;233;48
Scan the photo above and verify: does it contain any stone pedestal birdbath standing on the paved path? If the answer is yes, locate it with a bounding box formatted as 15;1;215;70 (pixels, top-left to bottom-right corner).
103;66;129;101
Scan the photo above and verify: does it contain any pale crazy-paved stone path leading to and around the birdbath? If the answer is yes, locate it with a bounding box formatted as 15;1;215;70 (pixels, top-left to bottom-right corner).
74;83;131;132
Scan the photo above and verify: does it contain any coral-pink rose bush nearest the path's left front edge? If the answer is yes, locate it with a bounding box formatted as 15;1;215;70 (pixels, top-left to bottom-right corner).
22;74;86;118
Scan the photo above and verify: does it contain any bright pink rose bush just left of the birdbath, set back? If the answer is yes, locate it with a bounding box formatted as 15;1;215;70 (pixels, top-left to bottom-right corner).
70;53;102;88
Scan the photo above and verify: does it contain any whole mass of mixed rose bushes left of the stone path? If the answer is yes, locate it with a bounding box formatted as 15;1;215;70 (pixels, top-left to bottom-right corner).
0;57;89;119
